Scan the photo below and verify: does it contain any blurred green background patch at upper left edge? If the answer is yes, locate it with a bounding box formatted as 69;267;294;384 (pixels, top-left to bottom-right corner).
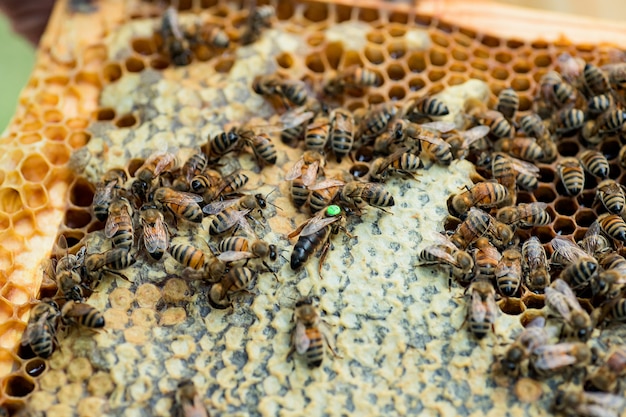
0;15;35;134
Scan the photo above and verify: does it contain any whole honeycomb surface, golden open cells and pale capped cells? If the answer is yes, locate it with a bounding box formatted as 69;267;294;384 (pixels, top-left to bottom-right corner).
0;0;626;416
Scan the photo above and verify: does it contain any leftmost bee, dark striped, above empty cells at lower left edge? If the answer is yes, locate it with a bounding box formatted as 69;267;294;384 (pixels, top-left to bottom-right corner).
21;300;61;359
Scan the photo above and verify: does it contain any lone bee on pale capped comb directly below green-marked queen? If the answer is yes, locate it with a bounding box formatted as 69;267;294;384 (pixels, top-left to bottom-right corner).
289;297;340;368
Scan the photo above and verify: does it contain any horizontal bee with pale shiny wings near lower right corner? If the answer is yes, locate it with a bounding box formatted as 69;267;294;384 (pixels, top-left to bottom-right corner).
528;342;593;378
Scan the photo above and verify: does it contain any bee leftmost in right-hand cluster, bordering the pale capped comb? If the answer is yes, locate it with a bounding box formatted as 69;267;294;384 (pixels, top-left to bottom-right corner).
418;233;474;281
